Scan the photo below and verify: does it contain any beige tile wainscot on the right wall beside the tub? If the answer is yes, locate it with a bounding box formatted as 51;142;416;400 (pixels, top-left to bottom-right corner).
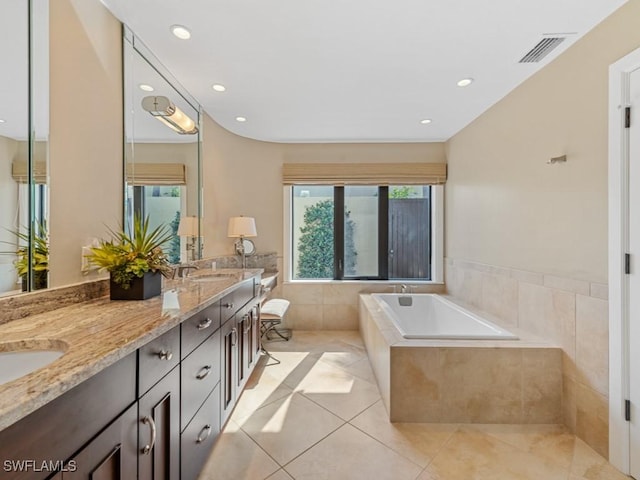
445;258;609;457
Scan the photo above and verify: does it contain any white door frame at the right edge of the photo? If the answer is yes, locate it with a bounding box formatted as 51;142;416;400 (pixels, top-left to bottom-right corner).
609;48;640;474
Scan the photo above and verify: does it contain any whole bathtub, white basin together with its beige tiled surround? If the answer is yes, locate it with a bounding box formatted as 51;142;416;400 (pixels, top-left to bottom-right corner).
358;293;564;424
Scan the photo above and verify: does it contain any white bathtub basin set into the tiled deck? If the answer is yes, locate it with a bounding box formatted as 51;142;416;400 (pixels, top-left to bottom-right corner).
371;293;518;340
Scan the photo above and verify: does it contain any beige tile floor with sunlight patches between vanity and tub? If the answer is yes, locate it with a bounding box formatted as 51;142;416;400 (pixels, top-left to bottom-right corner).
200;331;629;480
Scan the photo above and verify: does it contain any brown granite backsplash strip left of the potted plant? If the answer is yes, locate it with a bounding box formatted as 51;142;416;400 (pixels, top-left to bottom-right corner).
0;280;109;324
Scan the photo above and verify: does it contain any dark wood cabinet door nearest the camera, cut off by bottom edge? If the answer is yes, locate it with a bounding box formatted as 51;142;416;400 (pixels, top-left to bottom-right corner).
62;404;138;480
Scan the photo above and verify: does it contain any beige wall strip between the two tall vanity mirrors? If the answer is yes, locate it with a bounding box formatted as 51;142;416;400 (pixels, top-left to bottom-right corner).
49;0;123;286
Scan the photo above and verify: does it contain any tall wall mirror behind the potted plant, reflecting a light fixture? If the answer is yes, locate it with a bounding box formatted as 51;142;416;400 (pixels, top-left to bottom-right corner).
123;28;202;263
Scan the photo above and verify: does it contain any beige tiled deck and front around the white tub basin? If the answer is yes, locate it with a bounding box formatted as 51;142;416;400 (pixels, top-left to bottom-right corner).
359;295;562;424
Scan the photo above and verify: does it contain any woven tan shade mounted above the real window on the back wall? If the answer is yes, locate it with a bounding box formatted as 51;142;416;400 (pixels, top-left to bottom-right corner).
282;163;447;185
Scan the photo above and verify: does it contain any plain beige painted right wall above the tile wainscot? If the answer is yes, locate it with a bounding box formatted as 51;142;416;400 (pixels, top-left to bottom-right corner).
446;0;640;282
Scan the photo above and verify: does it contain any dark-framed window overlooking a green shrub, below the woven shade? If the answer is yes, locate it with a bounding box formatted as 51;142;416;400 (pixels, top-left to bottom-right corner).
290;185;441;280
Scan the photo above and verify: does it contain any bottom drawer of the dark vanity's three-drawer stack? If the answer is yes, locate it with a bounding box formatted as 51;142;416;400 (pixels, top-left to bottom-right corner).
180;385;220;480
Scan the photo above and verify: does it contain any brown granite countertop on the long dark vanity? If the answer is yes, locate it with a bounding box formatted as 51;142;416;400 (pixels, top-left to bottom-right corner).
0;269;263;430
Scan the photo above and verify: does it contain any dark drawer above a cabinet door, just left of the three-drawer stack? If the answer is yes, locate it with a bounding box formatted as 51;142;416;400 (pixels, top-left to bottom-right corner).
138;326;180;396
